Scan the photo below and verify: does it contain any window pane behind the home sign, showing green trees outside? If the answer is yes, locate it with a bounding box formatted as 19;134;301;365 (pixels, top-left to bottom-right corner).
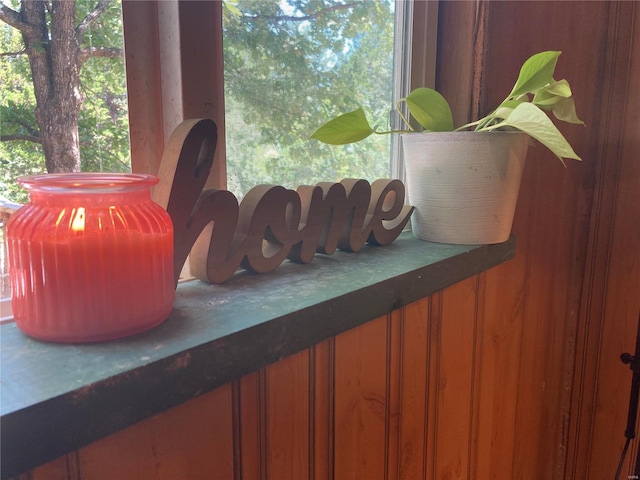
224;0;395;196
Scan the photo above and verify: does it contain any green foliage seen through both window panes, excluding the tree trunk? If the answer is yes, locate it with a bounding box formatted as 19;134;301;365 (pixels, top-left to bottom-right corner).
0;0;394;203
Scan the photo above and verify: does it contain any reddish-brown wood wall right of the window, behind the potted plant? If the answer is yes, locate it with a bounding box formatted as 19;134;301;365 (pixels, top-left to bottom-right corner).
460;1;640;480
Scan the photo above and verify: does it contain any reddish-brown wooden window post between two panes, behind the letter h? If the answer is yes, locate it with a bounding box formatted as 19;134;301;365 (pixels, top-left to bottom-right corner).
122;0;226;189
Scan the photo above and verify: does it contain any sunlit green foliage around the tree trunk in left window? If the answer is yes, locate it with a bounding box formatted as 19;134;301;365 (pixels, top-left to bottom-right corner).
0;0;130;203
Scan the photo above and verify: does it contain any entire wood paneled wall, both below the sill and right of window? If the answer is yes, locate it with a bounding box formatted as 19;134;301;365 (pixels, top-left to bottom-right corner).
12;1;640;480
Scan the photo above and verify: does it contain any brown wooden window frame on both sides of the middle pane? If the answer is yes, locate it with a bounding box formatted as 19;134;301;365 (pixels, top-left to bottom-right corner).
122;0;438;184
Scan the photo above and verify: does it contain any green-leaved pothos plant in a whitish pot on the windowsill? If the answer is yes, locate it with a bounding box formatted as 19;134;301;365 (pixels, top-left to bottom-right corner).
311;51;584;244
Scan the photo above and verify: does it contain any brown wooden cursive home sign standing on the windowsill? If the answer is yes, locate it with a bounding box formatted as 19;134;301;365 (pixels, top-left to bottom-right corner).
153;119;413;284
